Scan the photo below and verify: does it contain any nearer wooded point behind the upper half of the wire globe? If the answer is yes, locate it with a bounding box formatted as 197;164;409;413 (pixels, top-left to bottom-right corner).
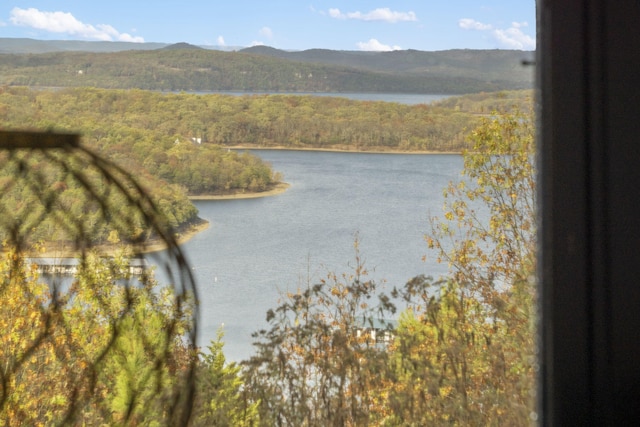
0;149;201;249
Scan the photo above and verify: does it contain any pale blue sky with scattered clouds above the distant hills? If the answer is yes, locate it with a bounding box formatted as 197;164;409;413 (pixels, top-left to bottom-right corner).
0;0;535;51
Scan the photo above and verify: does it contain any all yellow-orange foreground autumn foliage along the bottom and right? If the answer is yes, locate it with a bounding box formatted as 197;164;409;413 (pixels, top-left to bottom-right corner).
0;103;536;426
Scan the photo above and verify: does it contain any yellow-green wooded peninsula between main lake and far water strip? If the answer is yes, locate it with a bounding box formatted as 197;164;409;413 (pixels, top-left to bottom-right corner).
0;86;531;247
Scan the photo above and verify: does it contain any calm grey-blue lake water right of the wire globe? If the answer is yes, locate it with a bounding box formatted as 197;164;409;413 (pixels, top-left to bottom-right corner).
178;150;462;361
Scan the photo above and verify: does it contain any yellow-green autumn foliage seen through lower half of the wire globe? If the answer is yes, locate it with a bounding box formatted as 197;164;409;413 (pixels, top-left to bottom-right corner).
0;252;192;426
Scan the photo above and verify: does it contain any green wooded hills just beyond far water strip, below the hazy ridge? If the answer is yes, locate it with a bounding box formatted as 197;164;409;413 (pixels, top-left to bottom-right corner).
0;48;531;94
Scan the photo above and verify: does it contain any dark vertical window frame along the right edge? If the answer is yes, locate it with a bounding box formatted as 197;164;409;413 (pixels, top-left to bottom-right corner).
536;0;640;425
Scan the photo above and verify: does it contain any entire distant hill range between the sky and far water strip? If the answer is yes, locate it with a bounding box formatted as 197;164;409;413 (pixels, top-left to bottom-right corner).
0;38;534;94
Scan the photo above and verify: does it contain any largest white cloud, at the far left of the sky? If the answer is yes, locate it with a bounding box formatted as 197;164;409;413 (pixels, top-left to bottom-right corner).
10;7;144;43
